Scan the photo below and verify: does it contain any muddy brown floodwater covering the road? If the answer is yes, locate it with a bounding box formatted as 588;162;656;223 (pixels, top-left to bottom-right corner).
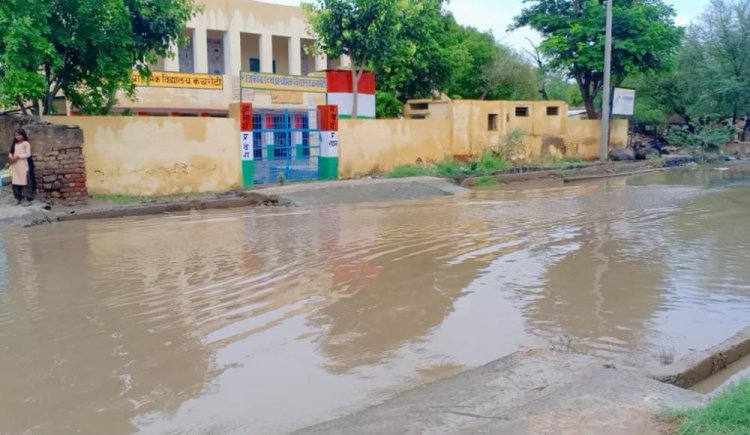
0;171;750;434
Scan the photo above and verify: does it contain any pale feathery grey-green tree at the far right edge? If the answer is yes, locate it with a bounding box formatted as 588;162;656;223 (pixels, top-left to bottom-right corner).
678;0;750;122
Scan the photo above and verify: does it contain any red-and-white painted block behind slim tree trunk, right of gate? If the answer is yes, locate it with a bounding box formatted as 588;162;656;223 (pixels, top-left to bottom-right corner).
326;70;375;119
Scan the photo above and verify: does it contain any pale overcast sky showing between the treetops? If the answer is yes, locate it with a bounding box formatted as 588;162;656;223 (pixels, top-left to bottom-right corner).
262;0;709;48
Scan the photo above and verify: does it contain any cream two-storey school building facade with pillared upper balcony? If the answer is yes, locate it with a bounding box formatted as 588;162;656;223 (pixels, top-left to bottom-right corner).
99;0;350;117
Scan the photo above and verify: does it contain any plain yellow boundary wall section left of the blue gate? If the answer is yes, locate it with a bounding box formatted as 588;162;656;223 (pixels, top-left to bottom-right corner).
45;116;241;196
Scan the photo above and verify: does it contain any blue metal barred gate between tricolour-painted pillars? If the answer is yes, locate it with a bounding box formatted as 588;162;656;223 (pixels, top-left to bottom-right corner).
253;109;320;184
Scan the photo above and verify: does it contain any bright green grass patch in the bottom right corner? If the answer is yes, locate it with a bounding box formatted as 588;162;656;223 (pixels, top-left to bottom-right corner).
676;381;750;435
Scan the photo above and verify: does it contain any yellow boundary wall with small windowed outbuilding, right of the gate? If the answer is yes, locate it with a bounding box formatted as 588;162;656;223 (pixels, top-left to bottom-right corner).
339;101;628;178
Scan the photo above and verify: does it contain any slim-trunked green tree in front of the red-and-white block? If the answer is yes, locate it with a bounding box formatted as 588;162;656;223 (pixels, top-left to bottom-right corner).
303;0;407;118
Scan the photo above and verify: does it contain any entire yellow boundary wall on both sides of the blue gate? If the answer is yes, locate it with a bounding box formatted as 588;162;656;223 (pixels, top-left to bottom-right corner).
46;101;628;196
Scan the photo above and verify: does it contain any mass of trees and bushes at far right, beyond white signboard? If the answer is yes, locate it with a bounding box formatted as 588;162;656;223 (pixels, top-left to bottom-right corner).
625;0;750;127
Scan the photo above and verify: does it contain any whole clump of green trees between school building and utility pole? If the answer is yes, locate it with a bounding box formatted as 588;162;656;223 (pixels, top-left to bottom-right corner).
304;0;539;108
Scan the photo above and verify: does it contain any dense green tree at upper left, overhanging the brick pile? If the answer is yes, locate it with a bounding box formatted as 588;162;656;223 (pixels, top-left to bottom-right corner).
0;0;196;114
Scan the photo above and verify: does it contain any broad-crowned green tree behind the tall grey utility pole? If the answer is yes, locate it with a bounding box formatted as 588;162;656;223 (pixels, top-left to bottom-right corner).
513;0;682;119
